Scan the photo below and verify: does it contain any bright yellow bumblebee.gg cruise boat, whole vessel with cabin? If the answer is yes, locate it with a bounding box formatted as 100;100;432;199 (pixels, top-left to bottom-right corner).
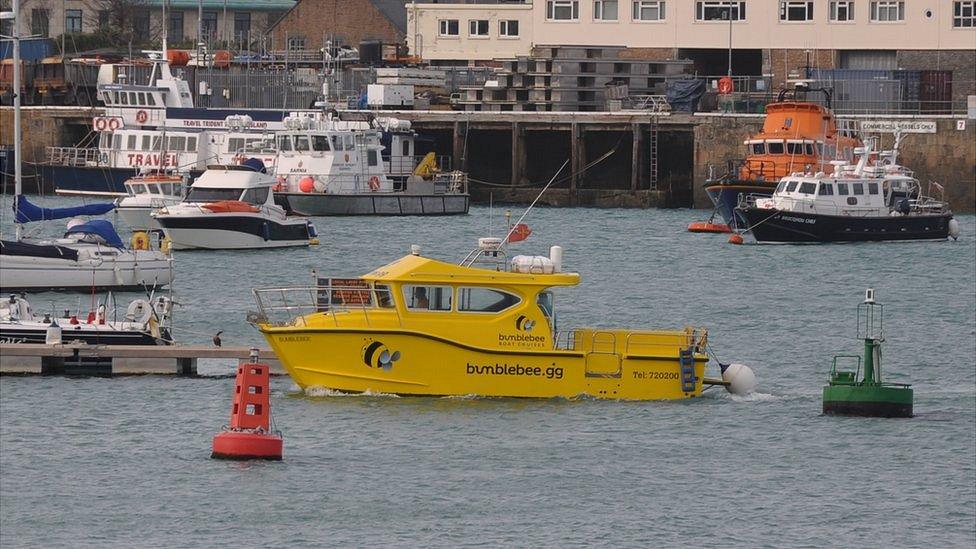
249;238;740;400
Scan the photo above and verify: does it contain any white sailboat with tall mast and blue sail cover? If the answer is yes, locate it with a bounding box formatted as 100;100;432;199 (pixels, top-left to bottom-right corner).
0;0;173;291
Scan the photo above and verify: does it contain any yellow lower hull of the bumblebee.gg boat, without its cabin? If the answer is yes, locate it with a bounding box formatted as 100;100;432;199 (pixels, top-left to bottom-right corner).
262;326;707;400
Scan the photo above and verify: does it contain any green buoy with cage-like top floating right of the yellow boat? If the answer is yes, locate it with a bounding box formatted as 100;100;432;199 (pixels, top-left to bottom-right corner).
823;288;914;417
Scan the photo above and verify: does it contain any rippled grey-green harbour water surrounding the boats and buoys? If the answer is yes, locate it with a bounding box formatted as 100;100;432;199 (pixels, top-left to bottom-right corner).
0;196;976;547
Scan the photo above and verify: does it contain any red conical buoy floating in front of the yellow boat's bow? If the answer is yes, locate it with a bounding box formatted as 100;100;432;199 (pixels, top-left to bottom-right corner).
210;349;283;460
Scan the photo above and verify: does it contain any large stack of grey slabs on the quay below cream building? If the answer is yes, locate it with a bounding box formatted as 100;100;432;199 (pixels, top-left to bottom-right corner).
456;46;693;112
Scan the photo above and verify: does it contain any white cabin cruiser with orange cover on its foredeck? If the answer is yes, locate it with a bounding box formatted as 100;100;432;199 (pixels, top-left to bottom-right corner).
153;159;317;250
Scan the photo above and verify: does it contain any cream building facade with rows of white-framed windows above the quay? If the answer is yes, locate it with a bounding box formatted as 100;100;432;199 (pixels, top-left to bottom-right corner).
407;0;976;84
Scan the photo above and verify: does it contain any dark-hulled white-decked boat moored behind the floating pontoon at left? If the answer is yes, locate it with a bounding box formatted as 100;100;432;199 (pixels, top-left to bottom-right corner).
0;294;173;345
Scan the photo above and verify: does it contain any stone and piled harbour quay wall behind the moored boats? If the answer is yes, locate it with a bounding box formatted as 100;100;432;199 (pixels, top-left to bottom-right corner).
0;107;976;212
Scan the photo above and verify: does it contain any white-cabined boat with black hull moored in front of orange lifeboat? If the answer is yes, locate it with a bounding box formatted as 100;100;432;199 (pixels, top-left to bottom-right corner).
737;137;959;242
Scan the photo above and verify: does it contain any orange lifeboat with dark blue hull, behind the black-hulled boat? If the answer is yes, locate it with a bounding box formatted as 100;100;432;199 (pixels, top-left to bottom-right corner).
705;84;861;228
